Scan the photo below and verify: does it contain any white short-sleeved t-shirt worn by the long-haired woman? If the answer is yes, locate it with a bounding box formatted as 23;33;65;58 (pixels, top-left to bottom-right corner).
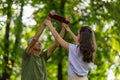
68;44;93;76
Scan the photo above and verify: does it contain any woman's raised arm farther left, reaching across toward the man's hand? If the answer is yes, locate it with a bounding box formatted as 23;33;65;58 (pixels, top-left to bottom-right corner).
45;19;69;50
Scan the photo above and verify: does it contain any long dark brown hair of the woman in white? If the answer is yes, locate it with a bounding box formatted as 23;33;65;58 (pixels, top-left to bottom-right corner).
78;26;96;63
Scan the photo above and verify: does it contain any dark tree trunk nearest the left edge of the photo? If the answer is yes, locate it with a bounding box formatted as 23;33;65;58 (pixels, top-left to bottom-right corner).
2;0;12;80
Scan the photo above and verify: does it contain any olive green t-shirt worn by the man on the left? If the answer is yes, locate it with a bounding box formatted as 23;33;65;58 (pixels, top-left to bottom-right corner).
21;51;47;80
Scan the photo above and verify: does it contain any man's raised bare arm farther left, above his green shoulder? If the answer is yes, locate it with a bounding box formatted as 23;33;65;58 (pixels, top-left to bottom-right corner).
26;23;45;54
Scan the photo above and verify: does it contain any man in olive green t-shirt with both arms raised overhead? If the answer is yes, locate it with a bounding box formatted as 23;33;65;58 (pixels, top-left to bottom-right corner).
21;14;69;80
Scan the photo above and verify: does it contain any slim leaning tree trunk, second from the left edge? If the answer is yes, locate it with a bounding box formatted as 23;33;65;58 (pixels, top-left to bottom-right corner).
12;0;24;60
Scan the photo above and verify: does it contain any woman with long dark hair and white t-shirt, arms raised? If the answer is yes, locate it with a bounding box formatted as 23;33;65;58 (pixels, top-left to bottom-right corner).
46;11;97;80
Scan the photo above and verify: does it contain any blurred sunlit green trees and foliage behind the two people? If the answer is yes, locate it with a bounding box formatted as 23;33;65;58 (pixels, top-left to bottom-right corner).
0;0;120;80
